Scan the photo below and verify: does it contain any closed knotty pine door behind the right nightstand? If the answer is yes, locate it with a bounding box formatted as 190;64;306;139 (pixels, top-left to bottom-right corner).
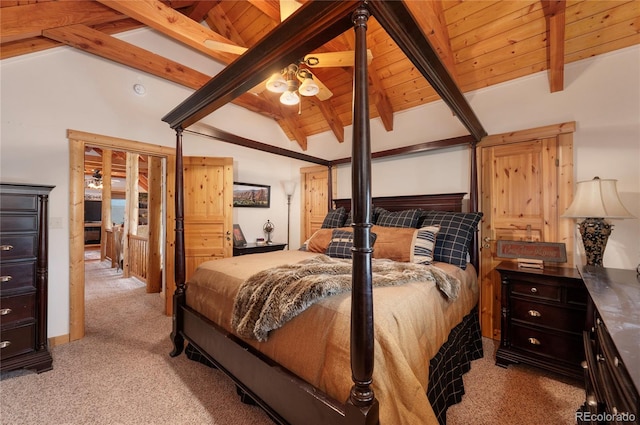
480;137;566;339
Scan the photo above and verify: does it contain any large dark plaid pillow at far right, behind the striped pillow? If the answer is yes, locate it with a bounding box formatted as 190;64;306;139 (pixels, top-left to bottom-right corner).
422;211;482;269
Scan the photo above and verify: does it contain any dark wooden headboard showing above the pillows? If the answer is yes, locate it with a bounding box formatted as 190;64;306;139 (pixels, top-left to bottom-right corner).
333;193;466;212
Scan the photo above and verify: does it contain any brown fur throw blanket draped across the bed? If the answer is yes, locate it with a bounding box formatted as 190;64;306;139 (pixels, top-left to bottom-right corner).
231;255;460;341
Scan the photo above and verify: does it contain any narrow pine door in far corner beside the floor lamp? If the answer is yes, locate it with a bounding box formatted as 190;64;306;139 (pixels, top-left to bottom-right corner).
300;166;337;243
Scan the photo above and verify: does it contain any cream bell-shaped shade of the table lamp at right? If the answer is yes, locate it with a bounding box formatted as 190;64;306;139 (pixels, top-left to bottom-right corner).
562;177;634;219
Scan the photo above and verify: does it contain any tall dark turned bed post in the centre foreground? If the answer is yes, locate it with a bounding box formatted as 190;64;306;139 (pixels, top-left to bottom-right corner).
349;7;378;423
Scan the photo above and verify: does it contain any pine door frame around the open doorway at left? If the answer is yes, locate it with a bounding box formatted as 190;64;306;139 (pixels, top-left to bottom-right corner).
68;129;176;342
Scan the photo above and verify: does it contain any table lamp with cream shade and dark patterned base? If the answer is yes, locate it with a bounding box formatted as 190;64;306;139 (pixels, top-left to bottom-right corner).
562;177;635;267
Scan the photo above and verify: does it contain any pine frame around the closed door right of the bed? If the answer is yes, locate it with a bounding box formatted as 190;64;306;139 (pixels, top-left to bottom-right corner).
476;121;576;339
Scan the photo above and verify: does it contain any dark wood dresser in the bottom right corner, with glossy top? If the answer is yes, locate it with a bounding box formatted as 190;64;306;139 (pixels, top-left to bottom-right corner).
576;266;640;424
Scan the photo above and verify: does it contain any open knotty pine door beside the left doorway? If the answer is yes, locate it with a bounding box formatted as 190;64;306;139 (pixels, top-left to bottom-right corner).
183;157;233;280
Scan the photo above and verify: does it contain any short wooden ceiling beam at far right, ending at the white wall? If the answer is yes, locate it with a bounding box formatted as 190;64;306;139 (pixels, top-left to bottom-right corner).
542;0;567;93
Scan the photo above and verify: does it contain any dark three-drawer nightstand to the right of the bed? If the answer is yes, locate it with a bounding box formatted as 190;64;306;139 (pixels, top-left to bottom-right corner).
496;262;588;378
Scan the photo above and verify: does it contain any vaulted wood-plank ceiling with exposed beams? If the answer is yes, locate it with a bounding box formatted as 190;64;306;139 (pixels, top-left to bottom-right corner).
0;0;640;150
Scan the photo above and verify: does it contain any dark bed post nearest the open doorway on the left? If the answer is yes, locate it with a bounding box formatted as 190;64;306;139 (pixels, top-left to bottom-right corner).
170;127;185;357
